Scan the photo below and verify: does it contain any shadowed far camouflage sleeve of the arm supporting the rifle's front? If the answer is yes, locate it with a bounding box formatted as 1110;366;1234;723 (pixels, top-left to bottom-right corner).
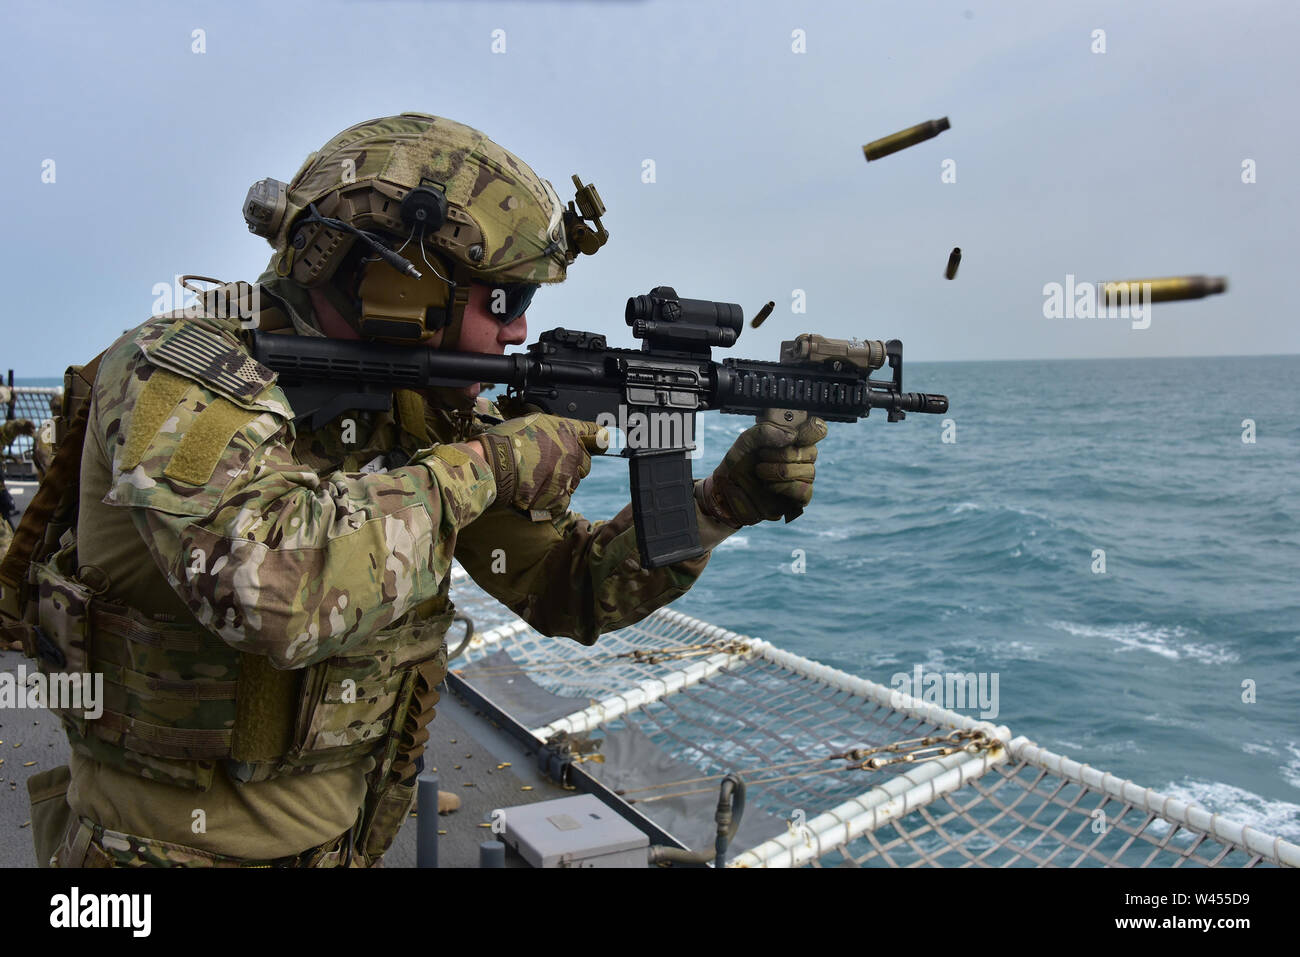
456;494;729;645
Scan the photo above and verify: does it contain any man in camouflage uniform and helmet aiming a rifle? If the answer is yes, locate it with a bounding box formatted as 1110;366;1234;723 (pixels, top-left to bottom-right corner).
29;114;826;866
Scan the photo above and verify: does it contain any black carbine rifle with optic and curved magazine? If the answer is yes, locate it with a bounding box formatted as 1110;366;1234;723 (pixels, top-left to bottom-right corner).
252;286;948;568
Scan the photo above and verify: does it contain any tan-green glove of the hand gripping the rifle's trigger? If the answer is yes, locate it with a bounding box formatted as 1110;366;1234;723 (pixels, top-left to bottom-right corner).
477;412;608;514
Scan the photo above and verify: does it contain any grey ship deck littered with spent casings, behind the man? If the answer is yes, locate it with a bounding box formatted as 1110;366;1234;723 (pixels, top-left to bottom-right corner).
0;651;573;867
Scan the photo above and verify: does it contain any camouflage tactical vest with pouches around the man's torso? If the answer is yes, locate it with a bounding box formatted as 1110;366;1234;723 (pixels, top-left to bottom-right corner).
7;283;473;789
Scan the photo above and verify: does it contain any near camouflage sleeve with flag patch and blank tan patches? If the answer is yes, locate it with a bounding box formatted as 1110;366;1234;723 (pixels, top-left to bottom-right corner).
87;324;495;668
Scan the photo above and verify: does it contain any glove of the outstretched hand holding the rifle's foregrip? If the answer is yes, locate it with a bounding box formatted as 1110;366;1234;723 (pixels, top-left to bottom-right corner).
699;417;826;528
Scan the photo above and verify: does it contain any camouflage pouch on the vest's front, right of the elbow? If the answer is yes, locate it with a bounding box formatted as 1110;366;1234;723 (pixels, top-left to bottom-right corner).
282;612;452;771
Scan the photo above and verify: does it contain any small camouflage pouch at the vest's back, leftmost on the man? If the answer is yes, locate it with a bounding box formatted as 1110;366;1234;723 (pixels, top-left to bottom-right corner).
29;542;103;735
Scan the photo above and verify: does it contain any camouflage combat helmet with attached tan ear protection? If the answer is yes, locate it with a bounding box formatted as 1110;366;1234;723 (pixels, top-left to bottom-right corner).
244;113;608;339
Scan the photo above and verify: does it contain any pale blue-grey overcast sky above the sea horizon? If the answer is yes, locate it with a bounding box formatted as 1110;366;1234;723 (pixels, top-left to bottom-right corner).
0;0;1300;377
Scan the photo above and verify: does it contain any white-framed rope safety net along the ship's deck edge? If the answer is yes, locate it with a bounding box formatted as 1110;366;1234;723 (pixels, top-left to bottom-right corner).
451;568;1300;867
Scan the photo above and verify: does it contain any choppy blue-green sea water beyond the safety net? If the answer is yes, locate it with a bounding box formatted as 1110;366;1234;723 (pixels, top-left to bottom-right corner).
573;356;1300;840
